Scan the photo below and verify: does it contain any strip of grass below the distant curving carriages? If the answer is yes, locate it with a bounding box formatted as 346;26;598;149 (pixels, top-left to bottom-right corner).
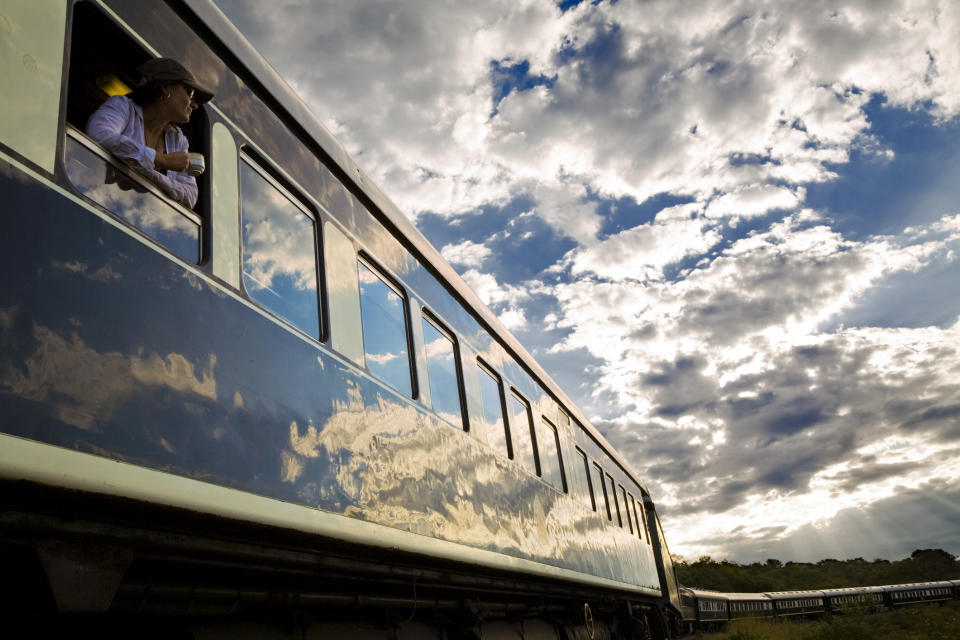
696;602;960;640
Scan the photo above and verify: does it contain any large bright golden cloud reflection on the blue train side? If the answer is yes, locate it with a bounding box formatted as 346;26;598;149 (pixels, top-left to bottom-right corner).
268;372;630;575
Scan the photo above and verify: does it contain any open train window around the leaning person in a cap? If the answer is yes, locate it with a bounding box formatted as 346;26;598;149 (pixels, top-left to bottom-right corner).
64;2;209;263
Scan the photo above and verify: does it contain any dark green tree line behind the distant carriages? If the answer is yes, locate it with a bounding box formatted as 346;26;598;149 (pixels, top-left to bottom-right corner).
675;549;960;592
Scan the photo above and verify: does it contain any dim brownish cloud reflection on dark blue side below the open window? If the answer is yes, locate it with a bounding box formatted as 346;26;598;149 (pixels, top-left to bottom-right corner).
0;322;217;431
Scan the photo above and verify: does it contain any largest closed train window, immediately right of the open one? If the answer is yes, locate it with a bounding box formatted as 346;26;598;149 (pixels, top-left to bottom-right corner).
240;158;320;338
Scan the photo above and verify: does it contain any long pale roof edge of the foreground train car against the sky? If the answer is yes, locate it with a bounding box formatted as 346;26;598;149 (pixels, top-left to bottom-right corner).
176;0;646;491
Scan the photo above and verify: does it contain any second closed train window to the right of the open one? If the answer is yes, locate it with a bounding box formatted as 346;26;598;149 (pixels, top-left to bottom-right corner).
357;260;413;396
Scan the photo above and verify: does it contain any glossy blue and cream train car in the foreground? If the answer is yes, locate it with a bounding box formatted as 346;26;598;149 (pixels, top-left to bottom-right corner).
0;0;679;638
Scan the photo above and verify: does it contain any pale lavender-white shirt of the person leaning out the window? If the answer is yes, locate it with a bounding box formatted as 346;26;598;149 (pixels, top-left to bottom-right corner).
87;96;197;209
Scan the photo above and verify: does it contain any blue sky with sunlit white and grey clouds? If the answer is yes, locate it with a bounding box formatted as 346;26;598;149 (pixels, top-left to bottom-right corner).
218;0;960;562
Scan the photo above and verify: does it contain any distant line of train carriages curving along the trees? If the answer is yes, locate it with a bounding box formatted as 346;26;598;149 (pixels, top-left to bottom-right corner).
680;580;960;633
